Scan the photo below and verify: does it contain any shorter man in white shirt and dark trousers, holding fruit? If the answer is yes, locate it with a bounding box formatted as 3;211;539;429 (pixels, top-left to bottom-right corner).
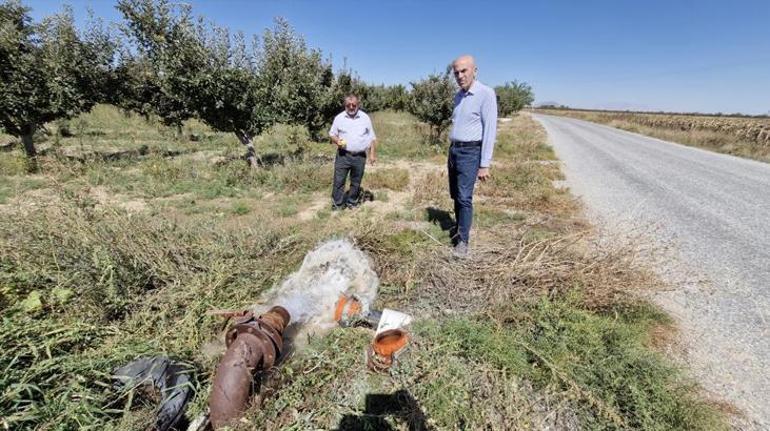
329;94;377;211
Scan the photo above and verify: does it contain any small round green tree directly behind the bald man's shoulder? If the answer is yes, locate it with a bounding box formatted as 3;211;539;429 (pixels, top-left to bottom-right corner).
409;69;457;144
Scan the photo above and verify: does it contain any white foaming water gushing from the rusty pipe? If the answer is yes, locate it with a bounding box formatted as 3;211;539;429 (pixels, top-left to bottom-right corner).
254;239;379;343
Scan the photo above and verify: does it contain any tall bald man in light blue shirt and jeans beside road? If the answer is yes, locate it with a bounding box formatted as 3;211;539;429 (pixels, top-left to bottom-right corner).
447;55;497;258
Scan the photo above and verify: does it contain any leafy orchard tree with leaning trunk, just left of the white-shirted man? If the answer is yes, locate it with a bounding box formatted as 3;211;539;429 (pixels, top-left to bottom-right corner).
192;19;333;167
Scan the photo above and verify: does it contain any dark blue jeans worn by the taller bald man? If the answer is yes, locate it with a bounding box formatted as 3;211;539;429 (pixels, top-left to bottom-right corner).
447;145;481;243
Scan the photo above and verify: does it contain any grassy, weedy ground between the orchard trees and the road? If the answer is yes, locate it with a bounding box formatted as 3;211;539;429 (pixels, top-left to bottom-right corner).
0;106;725;430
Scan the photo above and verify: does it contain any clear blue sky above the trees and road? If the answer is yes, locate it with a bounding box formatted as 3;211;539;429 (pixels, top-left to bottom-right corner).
22;0;770;114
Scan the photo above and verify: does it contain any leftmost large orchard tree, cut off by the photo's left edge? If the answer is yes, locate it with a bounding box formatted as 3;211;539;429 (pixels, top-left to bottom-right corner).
0;1;114;171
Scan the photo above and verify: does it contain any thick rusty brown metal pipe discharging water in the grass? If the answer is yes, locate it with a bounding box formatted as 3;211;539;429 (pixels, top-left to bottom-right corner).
209;306;291;429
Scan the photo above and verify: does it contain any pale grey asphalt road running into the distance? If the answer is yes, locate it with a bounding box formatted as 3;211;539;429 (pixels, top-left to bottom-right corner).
534;115;770;429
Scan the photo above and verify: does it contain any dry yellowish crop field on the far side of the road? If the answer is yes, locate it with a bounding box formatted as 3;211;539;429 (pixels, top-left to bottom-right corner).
536;109;770;162
